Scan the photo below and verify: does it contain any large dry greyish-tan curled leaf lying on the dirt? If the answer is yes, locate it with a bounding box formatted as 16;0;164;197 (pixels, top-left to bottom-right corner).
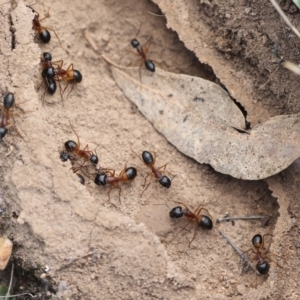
103;56;300;179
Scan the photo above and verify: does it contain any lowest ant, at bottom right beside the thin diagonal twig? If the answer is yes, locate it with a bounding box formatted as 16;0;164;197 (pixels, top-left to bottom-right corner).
245;233;280;275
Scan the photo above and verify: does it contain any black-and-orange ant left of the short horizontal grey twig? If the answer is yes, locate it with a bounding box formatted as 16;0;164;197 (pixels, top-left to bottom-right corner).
169;201;213;247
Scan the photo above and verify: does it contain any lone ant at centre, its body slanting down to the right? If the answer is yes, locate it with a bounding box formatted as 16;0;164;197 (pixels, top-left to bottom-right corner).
131;149;171;196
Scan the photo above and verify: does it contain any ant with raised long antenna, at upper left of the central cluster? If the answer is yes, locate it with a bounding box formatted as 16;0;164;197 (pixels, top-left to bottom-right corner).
60;124;99;166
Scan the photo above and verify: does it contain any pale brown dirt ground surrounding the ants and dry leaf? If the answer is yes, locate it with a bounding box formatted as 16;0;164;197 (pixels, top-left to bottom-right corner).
0;0;300;299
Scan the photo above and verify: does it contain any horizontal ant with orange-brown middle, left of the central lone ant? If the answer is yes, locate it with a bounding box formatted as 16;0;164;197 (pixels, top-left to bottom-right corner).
94;165;137;203
